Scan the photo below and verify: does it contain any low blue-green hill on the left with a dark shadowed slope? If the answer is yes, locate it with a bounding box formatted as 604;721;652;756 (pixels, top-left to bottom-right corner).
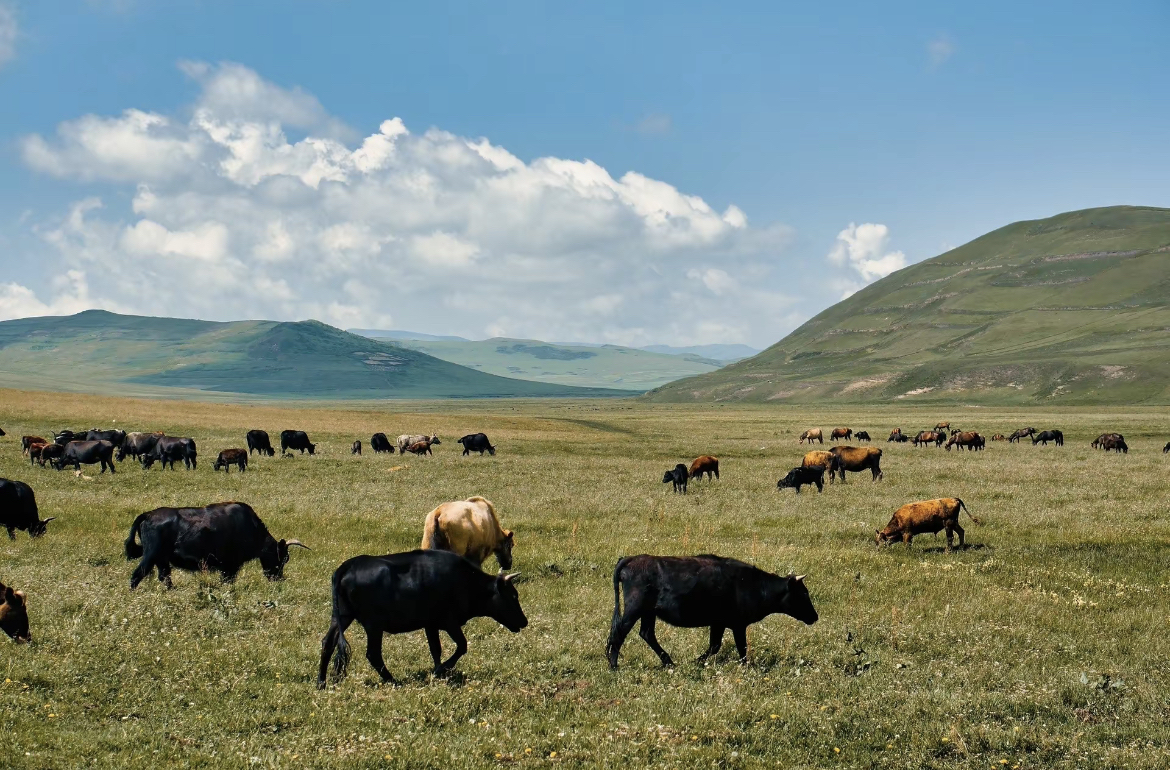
0;310;631;399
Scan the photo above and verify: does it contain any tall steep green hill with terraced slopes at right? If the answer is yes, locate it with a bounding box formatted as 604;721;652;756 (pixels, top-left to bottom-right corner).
646;206;1170;404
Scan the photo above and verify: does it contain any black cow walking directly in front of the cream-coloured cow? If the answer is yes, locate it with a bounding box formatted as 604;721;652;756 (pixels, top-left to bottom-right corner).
317;550;528;689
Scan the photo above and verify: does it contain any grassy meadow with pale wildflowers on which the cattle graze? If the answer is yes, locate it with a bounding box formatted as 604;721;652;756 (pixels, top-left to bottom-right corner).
0;391;1170;769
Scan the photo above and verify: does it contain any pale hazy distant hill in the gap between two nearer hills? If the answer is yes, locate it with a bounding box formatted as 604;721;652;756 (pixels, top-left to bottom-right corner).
362;337;723;392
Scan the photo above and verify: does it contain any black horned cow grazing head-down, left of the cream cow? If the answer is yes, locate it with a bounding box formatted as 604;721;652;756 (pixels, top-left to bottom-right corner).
125;502;309;590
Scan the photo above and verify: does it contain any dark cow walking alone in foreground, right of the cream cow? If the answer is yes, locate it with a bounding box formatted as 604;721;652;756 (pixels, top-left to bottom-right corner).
605;554;817;668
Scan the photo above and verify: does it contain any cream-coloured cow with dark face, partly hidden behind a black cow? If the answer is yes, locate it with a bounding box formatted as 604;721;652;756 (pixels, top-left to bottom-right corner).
419;495;515;570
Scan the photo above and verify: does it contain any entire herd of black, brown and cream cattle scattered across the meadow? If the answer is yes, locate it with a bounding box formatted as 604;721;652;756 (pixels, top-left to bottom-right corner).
0;422;1170;688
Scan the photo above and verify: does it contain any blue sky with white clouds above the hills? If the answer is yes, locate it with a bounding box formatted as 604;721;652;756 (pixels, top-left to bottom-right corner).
0;0;1170;348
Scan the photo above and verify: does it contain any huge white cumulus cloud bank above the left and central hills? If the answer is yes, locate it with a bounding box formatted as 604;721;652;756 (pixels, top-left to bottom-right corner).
11;62;795;344
